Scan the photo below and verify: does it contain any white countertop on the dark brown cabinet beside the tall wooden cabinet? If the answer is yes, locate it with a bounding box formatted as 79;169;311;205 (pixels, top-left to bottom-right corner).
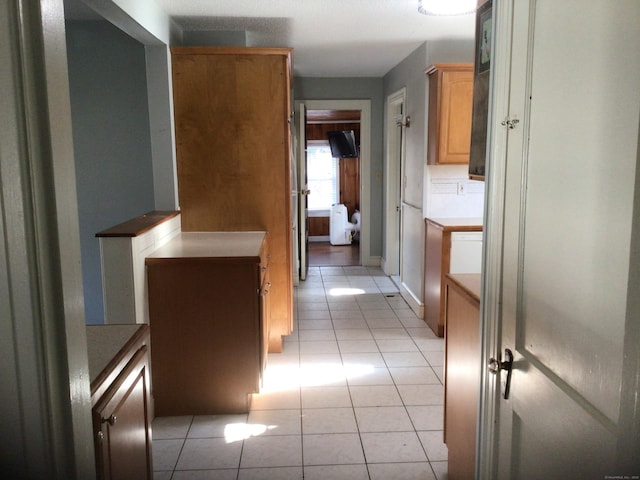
147;232;267;258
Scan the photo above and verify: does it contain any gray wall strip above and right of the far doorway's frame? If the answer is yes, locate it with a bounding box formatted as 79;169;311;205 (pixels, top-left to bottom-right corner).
293;77;384;257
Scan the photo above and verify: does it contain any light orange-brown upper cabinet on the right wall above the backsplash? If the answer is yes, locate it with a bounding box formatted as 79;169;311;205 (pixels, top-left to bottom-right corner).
427;63;473;165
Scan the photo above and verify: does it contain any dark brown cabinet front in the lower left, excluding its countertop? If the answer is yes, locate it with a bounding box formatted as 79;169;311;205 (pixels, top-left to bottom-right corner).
92;345;153;480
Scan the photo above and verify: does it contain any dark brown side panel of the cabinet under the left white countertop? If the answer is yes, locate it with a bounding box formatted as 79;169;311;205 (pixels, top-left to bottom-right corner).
148;260;261;416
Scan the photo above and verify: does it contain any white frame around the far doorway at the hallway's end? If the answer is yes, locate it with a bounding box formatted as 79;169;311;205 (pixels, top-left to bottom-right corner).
295;99;372;266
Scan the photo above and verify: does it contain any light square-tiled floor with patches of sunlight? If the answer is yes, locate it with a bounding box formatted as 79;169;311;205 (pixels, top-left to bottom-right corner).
153;267;447;480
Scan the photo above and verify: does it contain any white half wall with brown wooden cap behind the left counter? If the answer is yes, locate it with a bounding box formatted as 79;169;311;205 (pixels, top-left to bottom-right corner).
96;211;180;324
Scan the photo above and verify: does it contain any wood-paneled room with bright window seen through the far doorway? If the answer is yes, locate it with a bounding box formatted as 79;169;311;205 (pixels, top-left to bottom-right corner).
305;109;361;267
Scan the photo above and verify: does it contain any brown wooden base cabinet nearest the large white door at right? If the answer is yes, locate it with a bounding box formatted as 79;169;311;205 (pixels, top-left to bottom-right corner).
444;274;482;480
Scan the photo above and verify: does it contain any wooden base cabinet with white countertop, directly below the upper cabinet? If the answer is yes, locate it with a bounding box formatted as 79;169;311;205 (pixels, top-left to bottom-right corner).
424;218;482;337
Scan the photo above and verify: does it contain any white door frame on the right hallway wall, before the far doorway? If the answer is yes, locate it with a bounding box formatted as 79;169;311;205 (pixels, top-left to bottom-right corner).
382;88;407;278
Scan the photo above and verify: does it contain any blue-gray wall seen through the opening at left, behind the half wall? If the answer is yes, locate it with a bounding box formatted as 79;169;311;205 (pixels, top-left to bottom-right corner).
66;21;154;324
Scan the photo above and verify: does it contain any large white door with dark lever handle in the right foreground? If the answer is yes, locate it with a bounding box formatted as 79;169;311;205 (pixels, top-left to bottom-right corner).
479;0;640;479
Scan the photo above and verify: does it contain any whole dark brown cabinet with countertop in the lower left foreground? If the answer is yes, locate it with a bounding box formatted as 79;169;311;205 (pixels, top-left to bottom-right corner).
87;325;153;480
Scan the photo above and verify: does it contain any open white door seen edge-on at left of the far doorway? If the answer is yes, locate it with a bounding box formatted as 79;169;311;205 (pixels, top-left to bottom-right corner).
296;103;309;280
